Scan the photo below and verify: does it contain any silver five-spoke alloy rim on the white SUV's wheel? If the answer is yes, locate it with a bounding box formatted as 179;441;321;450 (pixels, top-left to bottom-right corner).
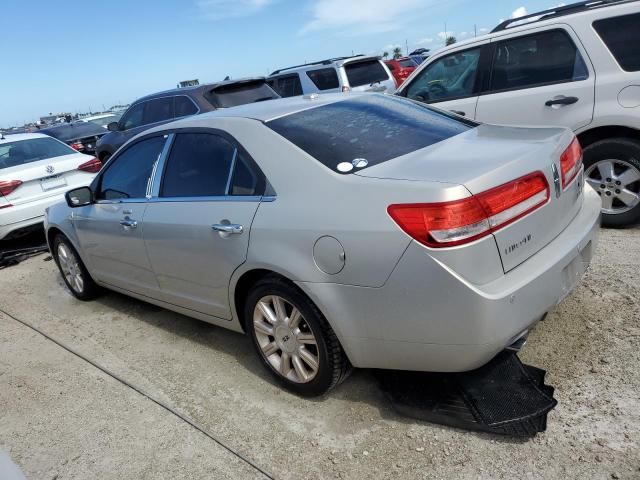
585;160;640;215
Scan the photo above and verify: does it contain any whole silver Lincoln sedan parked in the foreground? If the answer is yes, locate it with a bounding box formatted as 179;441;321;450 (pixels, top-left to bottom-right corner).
46;94;600;395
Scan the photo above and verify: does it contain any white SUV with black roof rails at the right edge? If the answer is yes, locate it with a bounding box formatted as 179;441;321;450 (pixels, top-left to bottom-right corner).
398;0;640;227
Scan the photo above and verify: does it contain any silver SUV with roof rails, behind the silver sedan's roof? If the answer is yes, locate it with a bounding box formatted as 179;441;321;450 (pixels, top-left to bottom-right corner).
267;55;396;97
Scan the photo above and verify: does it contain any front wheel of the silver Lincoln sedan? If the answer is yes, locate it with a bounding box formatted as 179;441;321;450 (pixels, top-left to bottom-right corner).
53;235;100;301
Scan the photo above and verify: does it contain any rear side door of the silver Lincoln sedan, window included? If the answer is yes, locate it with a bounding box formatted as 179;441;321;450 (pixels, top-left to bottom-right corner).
144;130;265;319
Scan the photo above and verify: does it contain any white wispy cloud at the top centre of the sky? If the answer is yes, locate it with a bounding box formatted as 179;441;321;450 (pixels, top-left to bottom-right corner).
302;0;433;33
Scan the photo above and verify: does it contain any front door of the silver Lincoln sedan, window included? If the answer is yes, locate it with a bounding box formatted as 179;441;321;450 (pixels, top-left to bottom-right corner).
73;135;166;297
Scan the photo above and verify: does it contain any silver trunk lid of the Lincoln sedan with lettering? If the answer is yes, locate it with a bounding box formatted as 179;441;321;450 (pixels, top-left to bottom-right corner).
357;125;583;273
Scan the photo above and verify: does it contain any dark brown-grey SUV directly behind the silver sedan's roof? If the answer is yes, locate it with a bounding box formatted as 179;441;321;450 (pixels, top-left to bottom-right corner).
96;77;279;162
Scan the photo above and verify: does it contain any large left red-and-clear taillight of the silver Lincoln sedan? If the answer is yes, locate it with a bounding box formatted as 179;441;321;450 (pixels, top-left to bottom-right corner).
387;172;549;248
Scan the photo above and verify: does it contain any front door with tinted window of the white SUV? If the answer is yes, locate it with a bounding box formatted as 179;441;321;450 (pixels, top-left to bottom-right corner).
399;46;488;119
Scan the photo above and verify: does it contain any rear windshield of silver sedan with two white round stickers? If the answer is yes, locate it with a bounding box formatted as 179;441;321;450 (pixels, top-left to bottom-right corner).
266;94;477;173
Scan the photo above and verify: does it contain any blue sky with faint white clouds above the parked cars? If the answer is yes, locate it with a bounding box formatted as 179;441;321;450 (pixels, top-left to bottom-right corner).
0;0;554;127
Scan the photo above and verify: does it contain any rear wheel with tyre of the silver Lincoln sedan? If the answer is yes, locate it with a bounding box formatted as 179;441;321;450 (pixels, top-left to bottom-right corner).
245;277;351;397
